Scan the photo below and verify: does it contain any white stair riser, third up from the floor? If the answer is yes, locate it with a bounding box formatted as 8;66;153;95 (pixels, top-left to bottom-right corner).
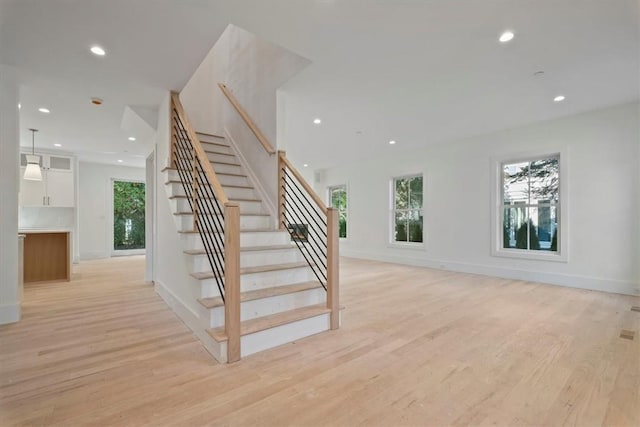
200;267;319;298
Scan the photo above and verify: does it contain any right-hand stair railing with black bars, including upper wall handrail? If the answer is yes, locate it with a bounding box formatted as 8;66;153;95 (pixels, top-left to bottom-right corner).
218;83;340;329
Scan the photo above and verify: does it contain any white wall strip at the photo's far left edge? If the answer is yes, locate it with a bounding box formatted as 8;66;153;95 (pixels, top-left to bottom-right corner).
0;65;22;324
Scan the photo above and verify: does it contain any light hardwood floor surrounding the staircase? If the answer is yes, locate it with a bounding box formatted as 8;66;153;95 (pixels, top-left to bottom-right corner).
0;257;640;426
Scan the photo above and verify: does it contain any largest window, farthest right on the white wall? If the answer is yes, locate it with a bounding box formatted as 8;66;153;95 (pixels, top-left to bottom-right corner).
500;154;560;254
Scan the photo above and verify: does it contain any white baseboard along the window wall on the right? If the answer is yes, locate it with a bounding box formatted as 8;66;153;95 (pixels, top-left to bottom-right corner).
340;250;640;295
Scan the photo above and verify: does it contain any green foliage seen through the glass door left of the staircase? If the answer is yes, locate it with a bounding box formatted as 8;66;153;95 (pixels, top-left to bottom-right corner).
113;181;145;250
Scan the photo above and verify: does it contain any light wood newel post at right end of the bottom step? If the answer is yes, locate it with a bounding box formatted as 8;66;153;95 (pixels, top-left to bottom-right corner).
327;208;340;329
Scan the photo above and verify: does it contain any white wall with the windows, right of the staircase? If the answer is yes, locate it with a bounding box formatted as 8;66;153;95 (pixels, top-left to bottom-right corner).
316;104;640;294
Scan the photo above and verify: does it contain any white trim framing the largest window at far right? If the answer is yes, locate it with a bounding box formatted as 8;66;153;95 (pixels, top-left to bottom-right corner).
491;149;569;263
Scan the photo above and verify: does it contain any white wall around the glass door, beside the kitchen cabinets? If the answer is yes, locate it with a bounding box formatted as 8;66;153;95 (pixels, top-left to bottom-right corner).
78;162;145;259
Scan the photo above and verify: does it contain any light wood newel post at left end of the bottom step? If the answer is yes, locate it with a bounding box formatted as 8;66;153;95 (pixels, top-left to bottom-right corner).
224;202;240;363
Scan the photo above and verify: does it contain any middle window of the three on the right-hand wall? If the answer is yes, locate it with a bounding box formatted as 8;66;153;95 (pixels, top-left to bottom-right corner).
391;175;423;243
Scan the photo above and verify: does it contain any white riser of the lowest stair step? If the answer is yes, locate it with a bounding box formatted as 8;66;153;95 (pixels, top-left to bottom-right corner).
240;313;330;357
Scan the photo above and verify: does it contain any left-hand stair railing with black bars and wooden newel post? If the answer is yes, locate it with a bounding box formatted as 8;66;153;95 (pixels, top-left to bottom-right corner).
171;93;240;362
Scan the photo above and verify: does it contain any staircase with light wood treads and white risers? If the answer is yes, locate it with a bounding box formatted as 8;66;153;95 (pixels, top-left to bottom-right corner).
163;129;332;362
